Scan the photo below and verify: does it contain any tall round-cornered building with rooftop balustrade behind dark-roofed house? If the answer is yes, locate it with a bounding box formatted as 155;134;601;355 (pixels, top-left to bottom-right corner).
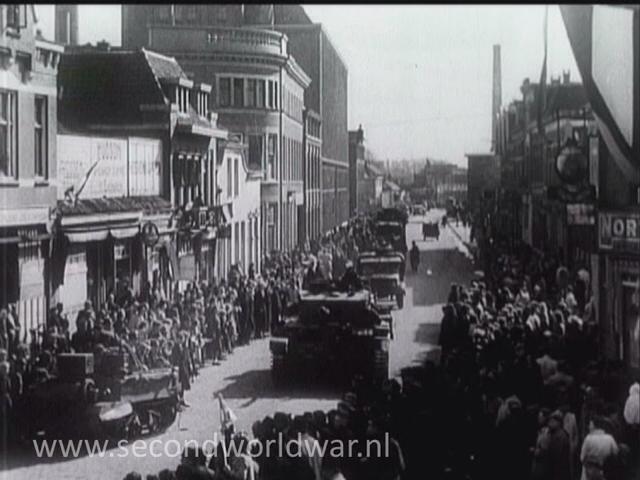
123;5;310;252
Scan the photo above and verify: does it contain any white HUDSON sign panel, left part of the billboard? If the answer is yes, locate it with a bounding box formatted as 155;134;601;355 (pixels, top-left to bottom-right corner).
58;135;127;198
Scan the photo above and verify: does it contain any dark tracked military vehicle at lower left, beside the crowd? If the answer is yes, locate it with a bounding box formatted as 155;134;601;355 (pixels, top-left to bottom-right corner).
18;347;181;441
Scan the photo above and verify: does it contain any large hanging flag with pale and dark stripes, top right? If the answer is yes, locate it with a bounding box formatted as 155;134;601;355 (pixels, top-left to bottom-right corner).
560;5;640;178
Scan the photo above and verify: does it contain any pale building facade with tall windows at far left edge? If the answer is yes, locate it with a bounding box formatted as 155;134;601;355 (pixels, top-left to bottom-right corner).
0;4;63;338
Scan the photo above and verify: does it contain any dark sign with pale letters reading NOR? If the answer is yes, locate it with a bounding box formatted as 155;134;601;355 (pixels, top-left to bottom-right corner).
598;212;640;252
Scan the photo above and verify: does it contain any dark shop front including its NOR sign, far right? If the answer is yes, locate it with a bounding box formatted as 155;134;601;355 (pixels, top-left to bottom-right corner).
598;211;640;374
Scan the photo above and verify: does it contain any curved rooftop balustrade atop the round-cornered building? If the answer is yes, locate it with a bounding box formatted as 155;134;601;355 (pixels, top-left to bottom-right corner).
149;25;288;58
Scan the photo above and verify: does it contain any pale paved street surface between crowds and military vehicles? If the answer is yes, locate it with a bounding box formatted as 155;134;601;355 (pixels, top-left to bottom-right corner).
5;211;472;480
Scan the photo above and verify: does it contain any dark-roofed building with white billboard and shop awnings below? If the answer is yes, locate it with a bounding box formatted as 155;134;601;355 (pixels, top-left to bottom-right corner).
52;48;227;318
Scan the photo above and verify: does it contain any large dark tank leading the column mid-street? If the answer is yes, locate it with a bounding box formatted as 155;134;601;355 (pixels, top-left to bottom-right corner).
270;283;390;385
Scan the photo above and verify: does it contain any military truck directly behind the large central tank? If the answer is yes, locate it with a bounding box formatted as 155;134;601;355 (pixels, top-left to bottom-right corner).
356;250;405;310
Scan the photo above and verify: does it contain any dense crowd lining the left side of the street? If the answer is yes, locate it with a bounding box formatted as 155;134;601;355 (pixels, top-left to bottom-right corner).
0;252;314;446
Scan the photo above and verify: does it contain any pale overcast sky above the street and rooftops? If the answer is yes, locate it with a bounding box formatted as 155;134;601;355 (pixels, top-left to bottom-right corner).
36;5;580;165
